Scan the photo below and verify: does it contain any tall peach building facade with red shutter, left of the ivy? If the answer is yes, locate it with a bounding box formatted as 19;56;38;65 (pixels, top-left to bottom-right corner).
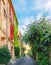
0;0;16;59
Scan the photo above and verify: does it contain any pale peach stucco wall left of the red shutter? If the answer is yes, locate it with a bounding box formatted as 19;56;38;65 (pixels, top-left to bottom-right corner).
0;0;14;59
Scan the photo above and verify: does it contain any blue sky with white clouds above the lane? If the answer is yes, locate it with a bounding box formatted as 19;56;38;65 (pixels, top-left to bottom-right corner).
12;0;51;34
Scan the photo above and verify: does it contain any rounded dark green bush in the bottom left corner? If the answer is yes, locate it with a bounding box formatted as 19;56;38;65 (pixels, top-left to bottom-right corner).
0;46;11;64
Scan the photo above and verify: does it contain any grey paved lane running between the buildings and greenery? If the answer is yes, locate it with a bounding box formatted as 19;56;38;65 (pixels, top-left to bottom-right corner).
9;56;37;65
